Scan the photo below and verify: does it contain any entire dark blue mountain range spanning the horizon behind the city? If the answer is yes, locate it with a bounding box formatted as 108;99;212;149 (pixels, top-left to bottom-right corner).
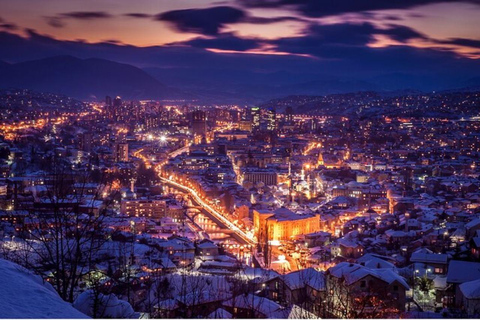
0;56;480;104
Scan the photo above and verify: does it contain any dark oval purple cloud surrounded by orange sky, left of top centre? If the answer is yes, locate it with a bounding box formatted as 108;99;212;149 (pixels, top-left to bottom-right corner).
155;6;246;35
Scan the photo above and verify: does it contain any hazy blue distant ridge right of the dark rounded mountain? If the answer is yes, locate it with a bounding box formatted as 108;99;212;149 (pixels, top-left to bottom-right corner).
144;67;477;104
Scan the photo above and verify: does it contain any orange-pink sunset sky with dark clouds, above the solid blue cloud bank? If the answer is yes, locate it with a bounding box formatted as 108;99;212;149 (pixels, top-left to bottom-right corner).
0;0;480;59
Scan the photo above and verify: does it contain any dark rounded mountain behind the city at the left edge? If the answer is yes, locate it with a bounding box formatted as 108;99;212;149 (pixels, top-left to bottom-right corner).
0;56;188;99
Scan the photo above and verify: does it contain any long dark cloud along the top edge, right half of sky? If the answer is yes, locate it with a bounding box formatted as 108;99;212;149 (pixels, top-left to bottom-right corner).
237;0;480;17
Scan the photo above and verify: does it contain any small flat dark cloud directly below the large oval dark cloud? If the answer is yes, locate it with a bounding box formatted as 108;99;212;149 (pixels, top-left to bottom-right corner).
171;33;261;51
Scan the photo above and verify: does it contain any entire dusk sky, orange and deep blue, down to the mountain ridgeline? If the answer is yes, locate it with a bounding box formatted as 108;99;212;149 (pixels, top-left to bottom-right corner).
0;0;480;85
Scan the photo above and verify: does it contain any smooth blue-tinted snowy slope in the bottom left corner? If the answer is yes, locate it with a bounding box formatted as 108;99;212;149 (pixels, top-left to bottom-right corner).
0;259;88;319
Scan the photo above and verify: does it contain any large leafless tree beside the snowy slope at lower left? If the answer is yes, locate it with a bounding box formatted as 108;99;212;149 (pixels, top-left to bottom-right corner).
6;159;118;302
